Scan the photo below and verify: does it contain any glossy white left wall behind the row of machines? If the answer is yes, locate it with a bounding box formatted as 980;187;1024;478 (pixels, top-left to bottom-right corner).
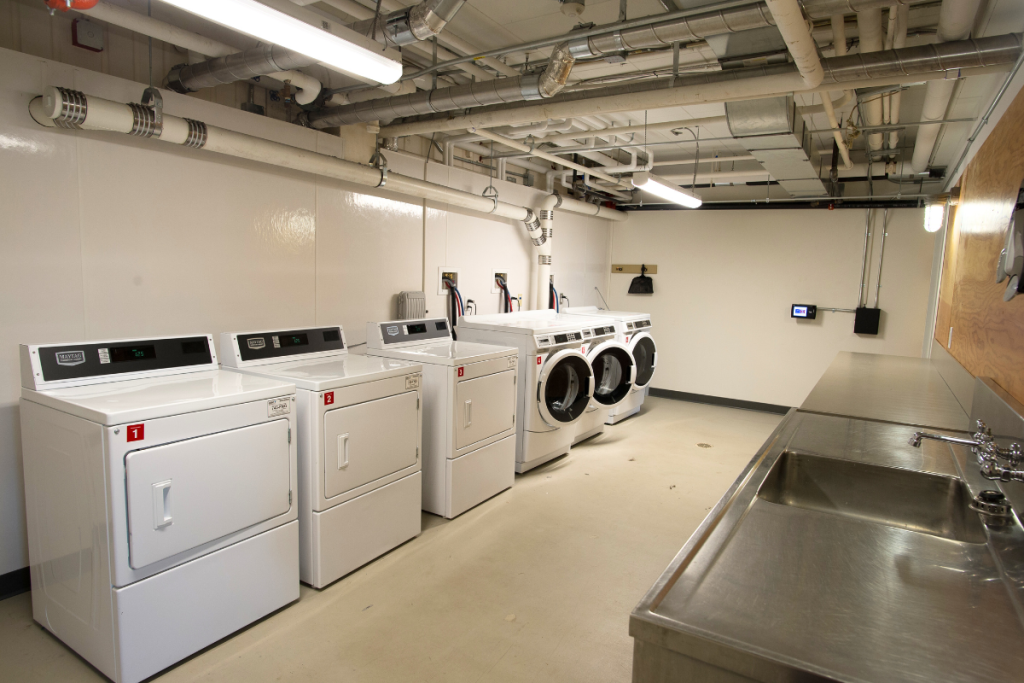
0;50;610;574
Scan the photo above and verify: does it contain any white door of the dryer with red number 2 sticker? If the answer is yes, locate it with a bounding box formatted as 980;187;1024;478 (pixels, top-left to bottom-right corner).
324;391;420;498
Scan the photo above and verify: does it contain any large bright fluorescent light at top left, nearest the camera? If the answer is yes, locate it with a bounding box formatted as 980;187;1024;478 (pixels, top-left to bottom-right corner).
157;0;401;84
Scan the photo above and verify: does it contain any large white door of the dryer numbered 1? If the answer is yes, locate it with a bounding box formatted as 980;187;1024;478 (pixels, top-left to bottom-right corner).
125;420;292;569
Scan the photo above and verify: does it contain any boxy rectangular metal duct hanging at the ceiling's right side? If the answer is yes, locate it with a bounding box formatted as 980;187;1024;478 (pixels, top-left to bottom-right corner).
725;95;827;197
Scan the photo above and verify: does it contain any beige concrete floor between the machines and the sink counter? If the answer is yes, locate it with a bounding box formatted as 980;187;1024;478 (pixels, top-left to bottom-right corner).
0;398;781;683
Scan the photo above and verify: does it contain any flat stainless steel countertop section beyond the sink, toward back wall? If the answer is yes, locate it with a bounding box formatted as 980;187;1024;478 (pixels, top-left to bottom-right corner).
800;351;973;431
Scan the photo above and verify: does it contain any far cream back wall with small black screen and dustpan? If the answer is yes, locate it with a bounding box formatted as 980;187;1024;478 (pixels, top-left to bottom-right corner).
608;209;935;405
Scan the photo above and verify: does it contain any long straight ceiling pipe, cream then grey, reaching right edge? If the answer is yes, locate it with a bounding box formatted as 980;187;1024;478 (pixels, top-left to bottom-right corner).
381;34;1021;137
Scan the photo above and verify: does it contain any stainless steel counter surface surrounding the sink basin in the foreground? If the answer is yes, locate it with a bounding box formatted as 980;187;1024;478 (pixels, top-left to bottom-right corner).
630;411;1024;683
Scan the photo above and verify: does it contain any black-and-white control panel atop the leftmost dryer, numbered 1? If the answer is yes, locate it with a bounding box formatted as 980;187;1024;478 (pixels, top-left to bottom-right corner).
20;335;217;390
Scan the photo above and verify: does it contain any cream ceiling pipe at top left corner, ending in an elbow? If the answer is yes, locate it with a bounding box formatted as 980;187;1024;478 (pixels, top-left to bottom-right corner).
76;0;322;104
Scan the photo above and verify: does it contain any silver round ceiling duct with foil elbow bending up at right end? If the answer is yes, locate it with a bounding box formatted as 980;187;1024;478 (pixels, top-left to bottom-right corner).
305;43;575;128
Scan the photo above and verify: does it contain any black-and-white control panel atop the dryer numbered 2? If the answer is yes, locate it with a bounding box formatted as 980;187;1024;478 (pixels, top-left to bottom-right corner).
220;325;348;368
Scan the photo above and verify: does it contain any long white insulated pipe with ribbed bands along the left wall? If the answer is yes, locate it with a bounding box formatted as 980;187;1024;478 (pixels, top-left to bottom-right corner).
29;86;627;227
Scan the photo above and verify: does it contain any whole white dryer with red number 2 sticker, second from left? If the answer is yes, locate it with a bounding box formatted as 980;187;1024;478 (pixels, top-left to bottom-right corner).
220;326;423;588
